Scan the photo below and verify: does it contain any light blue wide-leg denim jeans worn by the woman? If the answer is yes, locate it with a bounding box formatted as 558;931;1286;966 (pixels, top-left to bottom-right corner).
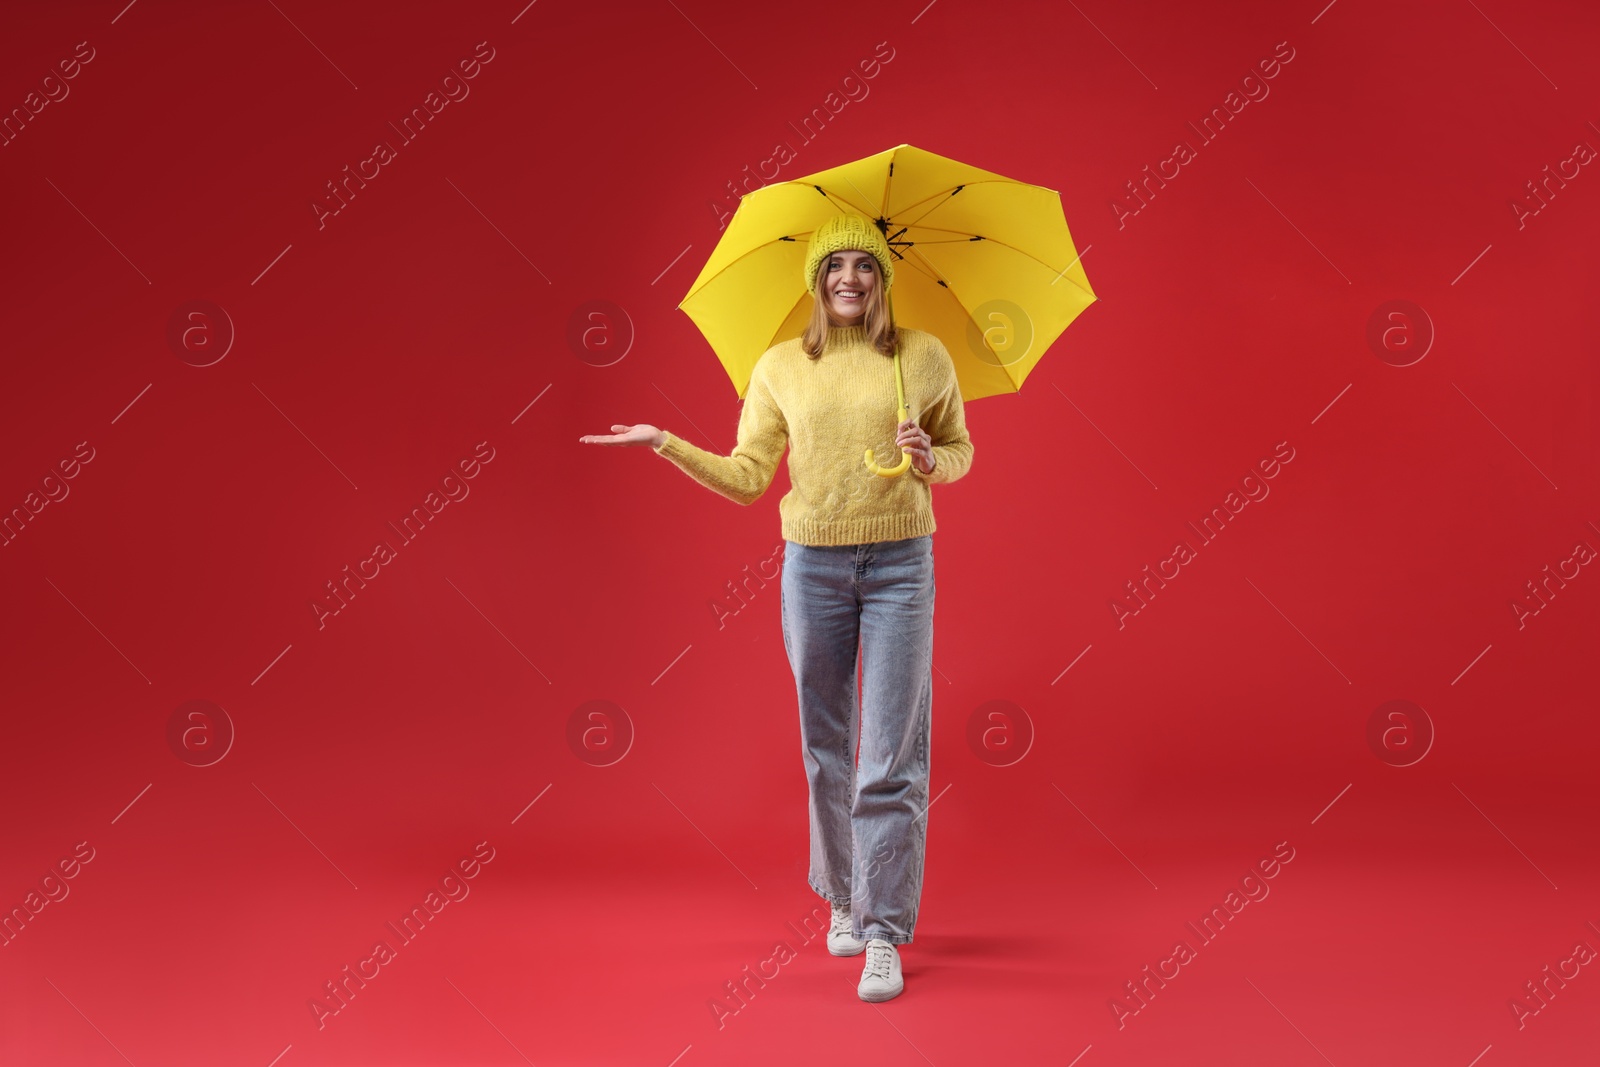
781;534;933;944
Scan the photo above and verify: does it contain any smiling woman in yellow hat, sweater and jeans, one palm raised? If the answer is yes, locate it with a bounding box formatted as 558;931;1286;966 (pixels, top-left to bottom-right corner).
579;214;973;1001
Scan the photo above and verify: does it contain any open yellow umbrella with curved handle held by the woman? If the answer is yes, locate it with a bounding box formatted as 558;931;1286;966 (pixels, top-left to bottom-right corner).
678;144;1096;475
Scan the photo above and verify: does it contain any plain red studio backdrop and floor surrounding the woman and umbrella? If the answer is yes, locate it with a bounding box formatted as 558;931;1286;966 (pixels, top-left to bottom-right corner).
0;0;1600;1067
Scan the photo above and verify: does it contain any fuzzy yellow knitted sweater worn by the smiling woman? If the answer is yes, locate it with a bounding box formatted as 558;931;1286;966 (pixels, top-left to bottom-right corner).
654;326;973;545
